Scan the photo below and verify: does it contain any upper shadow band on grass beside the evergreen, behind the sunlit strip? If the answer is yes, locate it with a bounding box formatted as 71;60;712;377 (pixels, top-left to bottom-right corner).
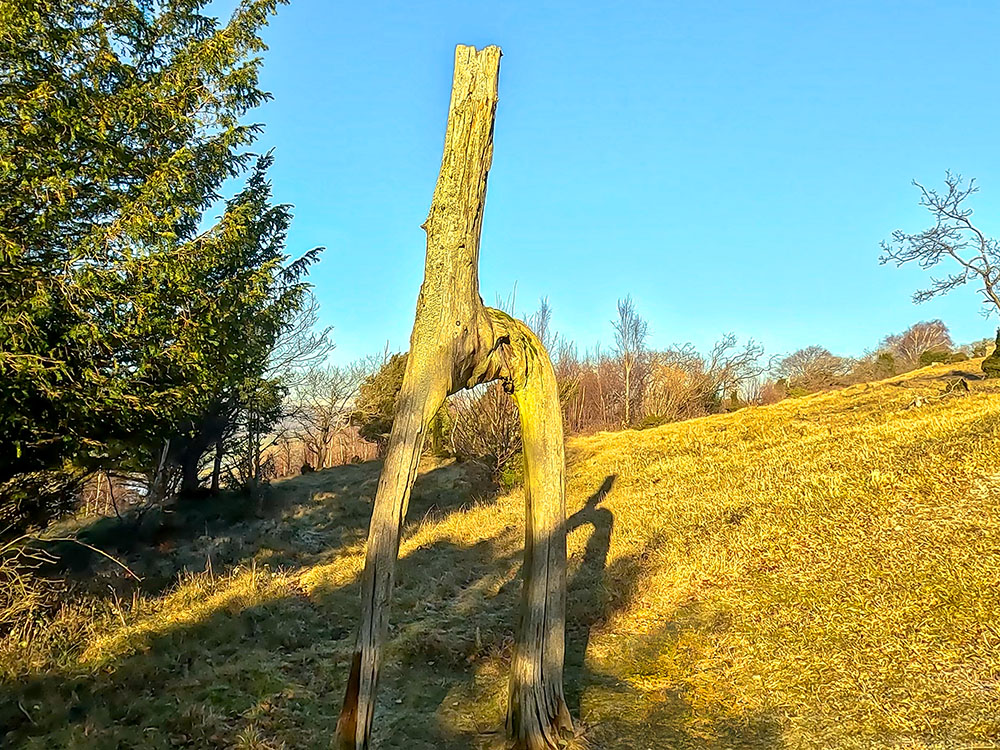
33;461;498;598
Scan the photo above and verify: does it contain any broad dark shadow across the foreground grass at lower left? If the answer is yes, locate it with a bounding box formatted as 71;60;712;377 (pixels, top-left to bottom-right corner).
0;541;516;750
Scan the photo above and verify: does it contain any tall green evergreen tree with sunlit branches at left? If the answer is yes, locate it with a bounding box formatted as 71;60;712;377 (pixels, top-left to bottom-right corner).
0;0;315;530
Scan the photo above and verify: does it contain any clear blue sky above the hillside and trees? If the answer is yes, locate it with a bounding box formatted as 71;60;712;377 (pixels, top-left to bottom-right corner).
240;0;1000;362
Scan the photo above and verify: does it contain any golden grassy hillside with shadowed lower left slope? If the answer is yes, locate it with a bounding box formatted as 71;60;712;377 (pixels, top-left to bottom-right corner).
0;361;1000;750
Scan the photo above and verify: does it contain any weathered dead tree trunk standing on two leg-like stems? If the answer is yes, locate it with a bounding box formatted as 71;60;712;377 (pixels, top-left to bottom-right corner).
337;46;572;750
